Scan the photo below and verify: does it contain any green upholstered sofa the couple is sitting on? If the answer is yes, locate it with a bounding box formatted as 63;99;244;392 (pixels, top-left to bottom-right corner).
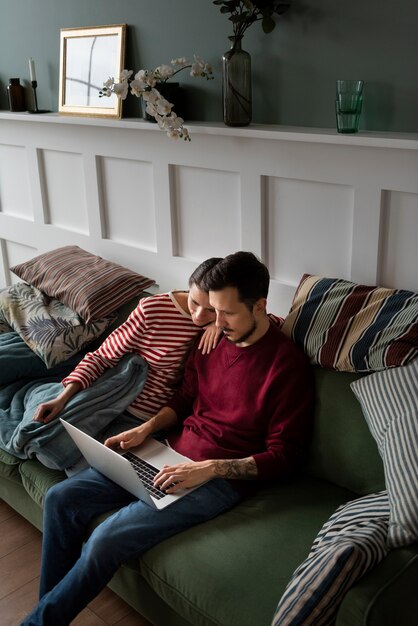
0;369;418;626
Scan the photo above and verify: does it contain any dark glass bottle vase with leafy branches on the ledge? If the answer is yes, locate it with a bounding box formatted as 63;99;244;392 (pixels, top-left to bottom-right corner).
213;0;290;126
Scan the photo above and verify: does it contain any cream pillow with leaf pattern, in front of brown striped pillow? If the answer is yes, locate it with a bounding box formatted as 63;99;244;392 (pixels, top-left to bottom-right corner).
0;283;115;368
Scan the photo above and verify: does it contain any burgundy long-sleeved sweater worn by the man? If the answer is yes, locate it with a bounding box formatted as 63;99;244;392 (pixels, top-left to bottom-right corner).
168;323;314;480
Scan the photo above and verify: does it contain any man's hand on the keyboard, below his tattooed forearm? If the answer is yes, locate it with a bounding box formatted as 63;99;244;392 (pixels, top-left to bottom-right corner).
154;461;214;493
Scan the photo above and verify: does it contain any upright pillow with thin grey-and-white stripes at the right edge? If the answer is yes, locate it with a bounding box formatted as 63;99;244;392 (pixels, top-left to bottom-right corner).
351;360;418;548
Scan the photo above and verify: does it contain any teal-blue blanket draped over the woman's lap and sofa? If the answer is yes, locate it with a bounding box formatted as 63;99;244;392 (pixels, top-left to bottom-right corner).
0;333;147;469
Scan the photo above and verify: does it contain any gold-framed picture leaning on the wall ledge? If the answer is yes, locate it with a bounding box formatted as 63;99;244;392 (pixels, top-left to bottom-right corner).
58;24;126;118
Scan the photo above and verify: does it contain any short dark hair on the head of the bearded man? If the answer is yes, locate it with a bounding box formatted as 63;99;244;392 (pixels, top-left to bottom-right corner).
202;251;270;309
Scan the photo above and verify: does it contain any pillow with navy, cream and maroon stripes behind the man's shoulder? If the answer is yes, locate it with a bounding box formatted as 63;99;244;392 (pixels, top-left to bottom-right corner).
282;274;418;372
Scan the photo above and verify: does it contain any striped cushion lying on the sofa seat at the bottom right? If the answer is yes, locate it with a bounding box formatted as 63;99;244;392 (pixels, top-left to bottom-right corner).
272;491;389;626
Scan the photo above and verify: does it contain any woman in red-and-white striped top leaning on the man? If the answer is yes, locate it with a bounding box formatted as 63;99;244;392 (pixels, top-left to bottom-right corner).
33;258;221;423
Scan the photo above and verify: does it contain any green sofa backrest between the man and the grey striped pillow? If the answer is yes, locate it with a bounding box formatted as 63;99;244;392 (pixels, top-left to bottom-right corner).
307;367;385;495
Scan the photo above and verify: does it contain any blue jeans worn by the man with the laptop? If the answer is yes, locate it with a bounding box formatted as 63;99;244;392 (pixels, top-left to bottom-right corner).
22;469;241;626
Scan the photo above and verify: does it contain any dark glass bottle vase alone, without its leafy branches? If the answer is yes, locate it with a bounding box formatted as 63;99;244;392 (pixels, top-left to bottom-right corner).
222;36;251;126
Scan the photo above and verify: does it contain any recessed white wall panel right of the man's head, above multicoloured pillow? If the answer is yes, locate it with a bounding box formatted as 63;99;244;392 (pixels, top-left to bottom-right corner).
265;176;354;284
